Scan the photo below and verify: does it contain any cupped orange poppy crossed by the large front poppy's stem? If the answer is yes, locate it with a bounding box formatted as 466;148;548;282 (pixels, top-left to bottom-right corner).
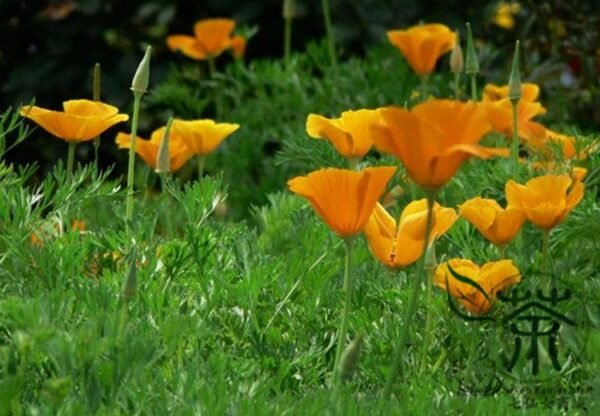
363;199;458;268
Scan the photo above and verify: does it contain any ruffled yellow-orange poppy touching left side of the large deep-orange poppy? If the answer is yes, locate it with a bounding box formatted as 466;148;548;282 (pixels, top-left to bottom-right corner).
306;110;379;159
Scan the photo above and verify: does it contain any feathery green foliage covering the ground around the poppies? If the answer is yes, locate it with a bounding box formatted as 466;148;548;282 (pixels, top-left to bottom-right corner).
0;40;600;415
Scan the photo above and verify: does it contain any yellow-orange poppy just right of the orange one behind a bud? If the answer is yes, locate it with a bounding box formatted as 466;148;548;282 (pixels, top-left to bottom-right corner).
171;119;240;155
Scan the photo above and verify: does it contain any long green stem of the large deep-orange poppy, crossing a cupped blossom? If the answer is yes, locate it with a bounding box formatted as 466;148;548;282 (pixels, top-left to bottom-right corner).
383;192;435;399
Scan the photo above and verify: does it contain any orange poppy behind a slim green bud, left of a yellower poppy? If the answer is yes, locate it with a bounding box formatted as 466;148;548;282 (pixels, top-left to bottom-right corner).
116;126;193;172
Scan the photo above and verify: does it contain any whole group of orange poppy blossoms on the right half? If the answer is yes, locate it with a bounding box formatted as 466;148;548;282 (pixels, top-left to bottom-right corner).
288;24;584;314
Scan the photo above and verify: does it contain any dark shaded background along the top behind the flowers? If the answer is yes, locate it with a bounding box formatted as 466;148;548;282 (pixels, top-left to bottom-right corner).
0;0;600;170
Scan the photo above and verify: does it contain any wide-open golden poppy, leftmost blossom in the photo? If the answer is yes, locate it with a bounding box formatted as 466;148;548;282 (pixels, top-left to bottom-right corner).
20;100;129;142
